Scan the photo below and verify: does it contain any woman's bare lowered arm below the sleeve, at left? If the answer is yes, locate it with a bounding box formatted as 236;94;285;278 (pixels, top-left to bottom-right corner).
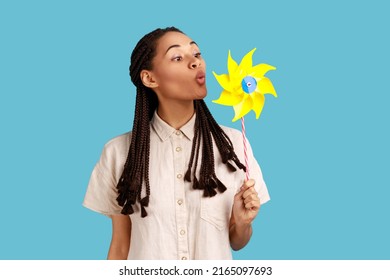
107;214;131;260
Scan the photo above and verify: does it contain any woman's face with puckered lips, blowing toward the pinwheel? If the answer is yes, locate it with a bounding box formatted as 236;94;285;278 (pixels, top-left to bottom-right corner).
148;32;207;102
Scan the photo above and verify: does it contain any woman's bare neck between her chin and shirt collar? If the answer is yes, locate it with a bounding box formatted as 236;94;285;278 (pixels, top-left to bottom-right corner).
157;101;195;129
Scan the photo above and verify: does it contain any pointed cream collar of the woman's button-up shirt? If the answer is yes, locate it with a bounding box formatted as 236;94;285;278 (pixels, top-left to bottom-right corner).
150;110;196;141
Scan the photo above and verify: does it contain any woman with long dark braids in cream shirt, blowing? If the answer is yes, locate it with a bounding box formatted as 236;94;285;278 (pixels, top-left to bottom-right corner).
83;27;269;260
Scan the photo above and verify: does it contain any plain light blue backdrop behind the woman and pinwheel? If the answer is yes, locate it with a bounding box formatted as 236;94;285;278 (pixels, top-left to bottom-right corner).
0;1;390;259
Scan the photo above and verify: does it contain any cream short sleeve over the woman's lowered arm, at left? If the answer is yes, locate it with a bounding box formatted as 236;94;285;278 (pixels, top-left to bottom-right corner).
83;140;122;216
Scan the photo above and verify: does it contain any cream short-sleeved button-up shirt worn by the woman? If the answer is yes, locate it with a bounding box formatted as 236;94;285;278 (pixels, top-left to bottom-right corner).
83;110;270;260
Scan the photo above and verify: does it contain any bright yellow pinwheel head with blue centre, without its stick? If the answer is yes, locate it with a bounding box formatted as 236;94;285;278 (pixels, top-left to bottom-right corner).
213;48;277;122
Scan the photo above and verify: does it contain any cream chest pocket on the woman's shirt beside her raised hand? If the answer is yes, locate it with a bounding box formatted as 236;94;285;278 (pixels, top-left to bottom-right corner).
200;189;234;231
